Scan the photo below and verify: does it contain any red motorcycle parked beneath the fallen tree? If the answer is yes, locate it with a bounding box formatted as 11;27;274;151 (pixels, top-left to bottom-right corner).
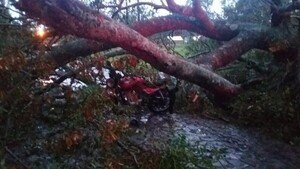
104;62;175;113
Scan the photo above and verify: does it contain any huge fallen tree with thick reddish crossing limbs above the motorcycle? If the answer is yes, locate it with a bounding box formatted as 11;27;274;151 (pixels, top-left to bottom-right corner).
15;0;300;98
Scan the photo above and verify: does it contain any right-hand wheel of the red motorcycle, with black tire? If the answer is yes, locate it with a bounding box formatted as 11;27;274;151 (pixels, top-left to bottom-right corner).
148;89;171;113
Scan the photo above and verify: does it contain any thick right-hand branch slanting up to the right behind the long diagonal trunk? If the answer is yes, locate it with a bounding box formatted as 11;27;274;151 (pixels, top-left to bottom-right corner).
189;25;297;70
